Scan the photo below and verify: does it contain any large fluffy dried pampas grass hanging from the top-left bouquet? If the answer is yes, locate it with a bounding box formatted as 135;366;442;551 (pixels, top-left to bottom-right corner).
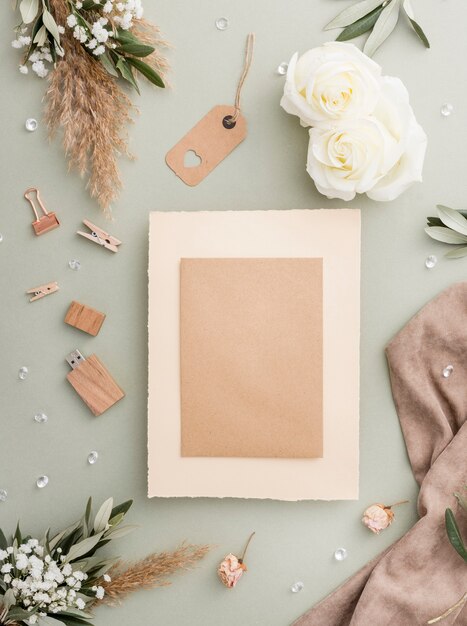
45;0;167;215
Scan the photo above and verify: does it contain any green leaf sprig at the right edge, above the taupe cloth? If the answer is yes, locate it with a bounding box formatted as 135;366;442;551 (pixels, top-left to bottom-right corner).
425;204;467;259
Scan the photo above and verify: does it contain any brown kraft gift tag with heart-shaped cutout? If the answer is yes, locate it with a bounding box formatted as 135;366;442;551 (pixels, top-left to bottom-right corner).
165;104;246;187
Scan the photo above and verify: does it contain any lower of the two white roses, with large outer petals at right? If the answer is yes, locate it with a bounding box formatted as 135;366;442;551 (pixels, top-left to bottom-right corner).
307;77;427;201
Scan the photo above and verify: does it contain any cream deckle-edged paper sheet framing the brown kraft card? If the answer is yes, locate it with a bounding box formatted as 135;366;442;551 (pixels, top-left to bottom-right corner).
148;209;360;500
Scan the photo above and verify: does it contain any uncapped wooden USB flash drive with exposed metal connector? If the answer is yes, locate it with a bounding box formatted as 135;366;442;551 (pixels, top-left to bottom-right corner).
66;350;125;416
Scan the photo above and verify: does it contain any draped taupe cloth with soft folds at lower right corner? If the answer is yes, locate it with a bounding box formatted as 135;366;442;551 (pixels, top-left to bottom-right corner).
294;282;467;626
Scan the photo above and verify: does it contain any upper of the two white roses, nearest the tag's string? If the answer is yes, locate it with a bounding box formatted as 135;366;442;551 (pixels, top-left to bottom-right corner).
281;42;381;126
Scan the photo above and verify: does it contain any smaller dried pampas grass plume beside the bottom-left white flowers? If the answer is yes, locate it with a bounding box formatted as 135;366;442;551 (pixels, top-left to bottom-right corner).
99;544;209;606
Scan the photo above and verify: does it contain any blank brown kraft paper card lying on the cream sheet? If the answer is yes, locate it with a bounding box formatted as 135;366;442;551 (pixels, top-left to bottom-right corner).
180;258;323;458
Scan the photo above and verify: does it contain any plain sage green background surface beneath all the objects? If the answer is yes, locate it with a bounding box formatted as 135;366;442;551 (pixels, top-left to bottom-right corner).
0;0;467;626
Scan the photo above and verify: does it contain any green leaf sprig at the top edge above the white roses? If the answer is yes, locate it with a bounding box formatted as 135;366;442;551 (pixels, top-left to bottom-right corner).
324;0;430;57
